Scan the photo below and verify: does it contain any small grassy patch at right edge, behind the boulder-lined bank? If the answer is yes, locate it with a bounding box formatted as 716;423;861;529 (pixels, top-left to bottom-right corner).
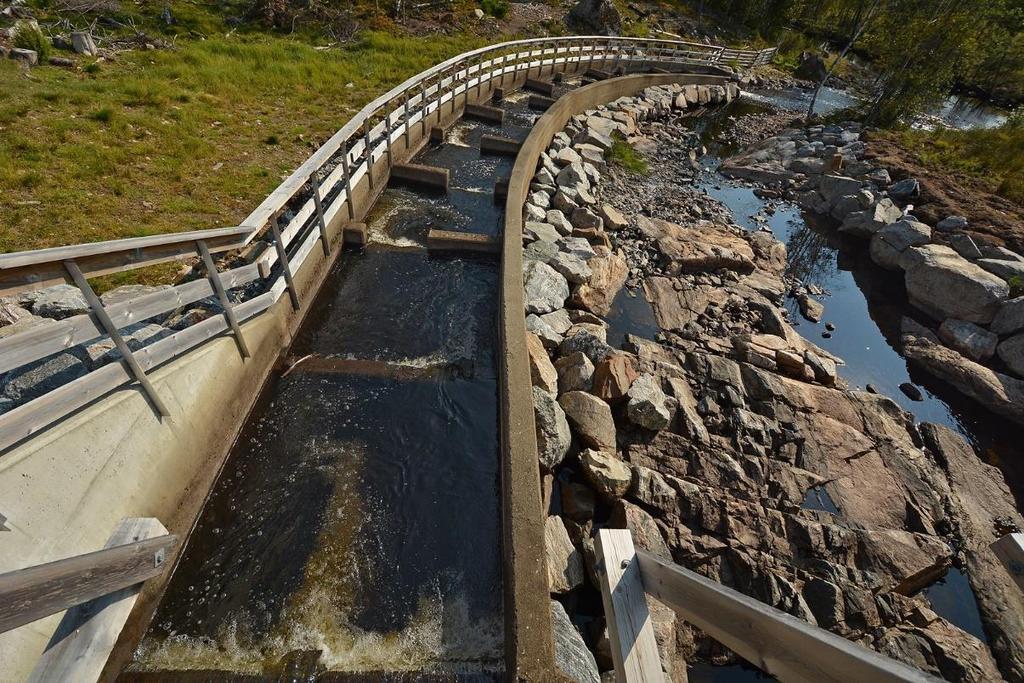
891;113;1024;206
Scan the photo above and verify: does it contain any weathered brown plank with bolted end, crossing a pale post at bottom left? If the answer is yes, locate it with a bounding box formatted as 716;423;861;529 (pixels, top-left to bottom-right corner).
0;535;178;633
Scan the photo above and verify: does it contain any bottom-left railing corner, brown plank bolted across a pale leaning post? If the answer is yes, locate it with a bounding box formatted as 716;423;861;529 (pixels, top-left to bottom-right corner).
0;517;178;683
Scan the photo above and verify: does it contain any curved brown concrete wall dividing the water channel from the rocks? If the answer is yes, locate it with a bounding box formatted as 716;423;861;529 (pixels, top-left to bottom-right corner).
499;68;729;681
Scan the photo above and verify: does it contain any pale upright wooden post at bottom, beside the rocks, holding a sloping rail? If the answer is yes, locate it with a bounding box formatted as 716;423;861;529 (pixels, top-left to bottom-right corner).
596;528;665;683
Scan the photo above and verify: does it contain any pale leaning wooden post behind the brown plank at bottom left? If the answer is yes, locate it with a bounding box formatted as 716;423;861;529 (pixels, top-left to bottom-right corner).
29;517;167;683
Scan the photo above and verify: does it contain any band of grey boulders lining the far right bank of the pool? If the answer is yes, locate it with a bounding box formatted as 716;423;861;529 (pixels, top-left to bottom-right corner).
721;124;1024;424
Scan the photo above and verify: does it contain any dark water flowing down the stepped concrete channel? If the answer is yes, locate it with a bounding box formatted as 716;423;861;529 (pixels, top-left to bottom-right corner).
123;88;561;680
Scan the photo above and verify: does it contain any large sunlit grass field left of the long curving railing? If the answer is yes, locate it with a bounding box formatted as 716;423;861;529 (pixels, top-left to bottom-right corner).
0;32;483;262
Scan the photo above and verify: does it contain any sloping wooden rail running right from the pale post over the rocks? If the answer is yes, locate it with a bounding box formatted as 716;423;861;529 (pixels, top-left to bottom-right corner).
634;552;939;683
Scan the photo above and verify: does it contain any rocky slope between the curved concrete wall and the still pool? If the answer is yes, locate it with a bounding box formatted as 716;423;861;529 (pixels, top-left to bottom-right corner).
523;82;1024;681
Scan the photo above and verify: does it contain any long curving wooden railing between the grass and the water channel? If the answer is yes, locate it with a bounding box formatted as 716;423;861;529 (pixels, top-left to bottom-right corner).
0;36;774;453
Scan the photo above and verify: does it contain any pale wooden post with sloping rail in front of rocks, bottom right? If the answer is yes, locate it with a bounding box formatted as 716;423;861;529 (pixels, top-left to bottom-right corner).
597;529;939;683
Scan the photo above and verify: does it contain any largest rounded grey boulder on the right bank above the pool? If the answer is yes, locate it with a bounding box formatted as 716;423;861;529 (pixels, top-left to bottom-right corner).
899;245;1010;323
